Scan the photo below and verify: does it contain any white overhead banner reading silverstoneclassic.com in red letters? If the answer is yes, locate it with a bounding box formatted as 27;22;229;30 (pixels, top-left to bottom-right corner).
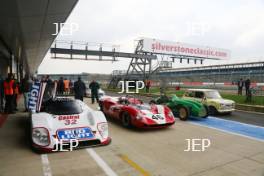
142;38;231;59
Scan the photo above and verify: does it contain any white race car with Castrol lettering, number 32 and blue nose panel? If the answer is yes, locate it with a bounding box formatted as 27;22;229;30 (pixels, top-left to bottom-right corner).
31;82;111;152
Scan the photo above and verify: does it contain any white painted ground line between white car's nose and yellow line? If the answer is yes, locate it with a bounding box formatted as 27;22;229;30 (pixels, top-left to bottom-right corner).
86;148;117;176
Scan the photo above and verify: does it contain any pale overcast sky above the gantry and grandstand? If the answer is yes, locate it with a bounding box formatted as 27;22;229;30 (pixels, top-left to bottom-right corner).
38;0;264;74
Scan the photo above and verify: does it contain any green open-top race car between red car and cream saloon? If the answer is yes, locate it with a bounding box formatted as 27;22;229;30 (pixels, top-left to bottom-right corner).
152;95;208;120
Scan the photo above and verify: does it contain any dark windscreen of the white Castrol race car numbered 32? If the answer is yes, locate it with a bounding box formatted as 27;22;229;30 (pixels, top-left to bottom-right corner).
45;100;82;115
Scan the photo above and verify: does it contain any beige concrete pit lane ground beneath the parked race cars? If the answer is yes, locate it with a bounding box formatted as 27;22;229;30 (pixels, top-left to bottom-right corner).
0;99;264;176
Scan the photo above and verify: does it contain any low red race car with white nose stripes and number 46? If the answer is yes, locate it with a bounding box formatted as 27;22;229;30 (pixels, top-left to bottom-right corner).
99;97;175;128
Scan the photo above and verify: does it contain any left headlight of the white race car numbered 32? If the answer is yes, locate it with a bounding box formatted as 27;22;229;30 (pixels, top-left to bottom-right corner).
32;127;50;147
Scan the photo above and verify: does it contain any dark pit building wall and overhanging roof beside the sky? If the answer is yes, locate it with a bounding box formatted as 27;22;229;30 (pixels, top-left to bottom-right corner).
0;0;78;80
